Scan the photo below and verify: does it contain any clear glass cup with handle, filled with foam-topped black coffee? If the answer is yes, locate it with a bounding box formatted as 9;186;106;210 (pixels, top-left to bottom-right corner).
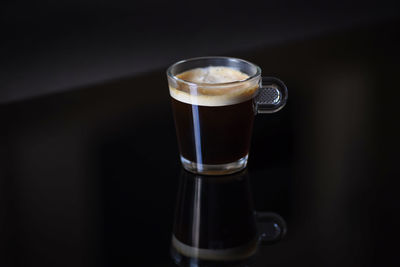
167;57;288;175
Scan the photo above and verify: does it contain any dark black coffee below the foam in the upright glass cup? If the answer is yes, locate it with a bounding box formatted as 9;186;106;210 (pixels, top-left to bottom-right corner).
172;98;254;164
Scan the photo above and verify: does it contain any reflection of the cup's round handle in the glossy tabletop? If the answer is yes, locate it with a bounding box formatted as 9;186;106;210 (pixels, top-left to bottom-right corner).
255;212;287;245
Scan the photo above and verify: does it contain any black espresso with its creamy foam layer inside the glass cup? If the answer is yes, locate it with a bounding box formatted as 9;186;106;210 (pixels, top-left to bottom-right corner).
170;66;258;168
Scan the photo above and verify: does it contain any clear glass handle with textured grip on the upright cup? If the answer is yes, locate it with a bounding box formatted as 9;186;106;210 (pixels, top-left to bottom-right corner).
255;77;288;114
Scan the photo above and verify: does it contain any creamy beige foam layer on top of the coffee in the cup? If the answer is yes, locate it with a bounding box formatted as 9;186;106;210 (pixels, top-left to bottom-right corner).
170;66;259;106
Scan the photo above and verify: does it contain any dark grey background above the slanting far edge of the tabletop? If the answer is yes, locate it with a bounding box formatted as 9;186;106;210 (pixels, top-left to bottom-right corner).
0;0;399;103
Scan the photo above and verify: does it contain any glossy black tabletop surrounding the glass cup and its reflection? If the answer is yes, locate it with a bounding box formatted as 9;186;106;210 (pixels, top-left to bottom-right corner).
0;22;400;266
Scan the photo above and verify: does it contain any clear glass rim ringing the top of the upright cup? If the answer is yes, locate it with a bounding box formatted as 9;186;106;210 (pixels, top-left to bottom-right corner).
167;56;261;87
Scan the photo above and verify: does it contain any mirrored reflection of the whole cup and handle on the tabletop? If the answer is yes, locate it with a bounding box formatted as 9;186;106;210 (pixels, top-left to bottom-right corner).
171;170;285;266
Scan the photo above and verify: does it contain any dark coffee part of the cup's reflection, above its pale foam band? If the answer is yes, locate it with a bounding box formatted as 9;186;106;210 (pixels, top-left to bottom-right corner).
173;170;258;250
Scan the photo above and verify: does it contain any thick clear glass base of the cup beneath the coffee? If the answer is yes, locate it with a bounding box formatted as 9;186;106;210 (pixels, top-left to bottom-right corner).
181;155;249;175
